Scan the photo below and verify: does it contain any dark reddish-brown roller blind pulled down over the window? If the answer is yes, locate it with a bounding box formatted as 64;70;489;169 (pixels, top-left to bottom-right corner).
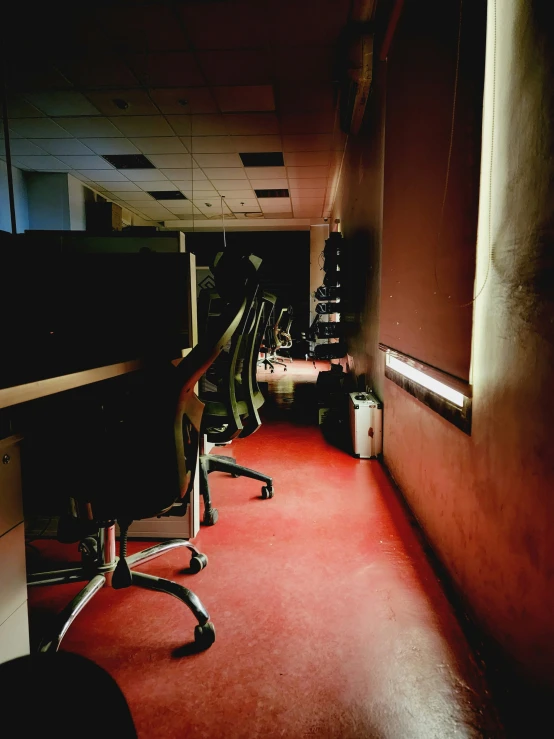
380;0;486;380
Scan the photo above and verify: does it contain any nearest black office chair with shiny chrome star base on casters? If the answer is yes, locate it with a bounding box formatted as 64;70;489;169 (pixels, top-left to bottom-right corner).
28;253;257;653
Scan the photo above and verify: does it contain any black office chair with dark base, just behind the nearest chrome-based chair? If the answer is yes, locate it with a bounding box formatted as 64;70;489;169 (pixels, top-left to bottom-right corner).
196;260;276;526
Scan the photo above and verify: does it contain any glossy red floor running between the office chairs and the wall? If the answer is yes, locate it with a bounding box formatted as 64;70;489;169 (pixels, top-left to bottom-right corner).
30;361;503;739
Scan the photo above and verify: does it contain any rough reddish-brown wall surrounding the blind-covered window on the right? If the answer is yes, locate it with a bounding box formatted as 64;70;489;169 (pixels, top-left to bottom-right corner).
337;0;554;686
